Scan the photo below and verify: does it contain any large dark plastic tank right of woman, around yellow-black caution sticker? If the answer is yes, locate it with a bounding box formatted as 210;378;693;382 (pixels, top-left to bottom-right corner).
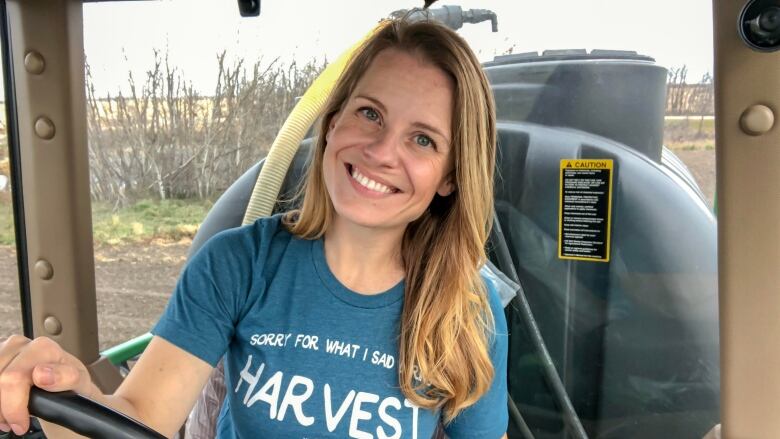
485;51;720;439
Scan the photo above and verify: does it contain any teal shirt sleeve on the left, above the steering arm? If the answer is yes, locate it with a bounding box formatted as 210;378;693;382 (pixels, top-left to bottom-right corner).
152;226;254;367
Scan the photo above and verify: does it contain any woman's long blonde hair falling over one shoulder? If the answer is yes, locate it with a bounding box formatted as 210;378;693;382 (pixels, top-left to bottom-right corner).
285;20;496;422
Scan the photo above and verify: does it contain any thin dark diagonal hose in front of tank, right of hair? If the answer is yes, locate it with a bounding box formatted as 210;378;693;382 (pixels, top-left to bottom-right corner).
492;217;588;439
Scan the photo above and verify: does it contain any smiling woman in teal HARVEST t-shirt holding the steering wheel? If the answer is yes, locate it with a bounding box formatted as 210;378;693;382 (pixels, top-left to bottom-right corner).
0;21;507;438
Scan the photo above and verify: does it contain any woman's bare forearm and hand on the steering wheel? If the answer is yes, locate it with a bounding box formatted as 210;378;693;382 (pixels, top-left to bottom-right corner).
0;335;212;437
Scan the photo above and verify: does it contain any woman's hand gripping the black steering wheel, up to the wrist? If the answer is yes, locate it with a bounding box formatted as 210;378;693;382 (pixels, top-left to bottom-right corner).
0;335;99;435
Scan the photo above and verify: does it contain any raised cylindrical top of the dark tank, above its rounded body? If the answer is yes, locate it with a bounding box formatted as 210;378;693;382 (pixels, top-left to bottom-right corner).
484;49;667;161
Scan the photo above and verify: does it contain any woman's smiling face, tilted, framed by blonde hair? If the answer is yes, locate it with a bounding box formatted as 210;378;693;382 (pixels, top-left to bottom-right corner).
323;49;454;234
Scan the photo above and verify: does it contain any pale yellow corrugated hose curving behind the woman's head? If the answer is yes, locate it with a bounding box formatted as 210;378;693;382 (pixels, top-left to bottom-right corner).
243;22;384;224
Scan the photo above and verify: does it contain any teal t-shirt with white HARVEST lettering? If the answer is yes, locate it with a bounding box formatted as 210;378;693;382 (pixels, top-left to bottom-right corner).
152;216;508;439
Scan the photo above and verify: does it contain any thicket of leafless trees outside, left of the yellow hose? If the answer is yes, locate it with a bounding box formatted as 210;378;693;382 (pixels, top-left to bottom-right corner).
86;51;325;205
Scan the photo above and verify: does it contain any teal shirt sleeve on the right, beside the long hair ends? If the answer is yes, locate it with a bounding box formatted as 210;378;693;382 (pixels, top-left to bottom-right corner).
444;280;509;439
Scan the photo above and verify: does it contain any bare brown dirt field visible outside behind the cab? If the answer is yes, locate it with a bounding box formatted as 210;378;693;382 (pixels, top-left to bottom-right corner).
0;149;715;349
